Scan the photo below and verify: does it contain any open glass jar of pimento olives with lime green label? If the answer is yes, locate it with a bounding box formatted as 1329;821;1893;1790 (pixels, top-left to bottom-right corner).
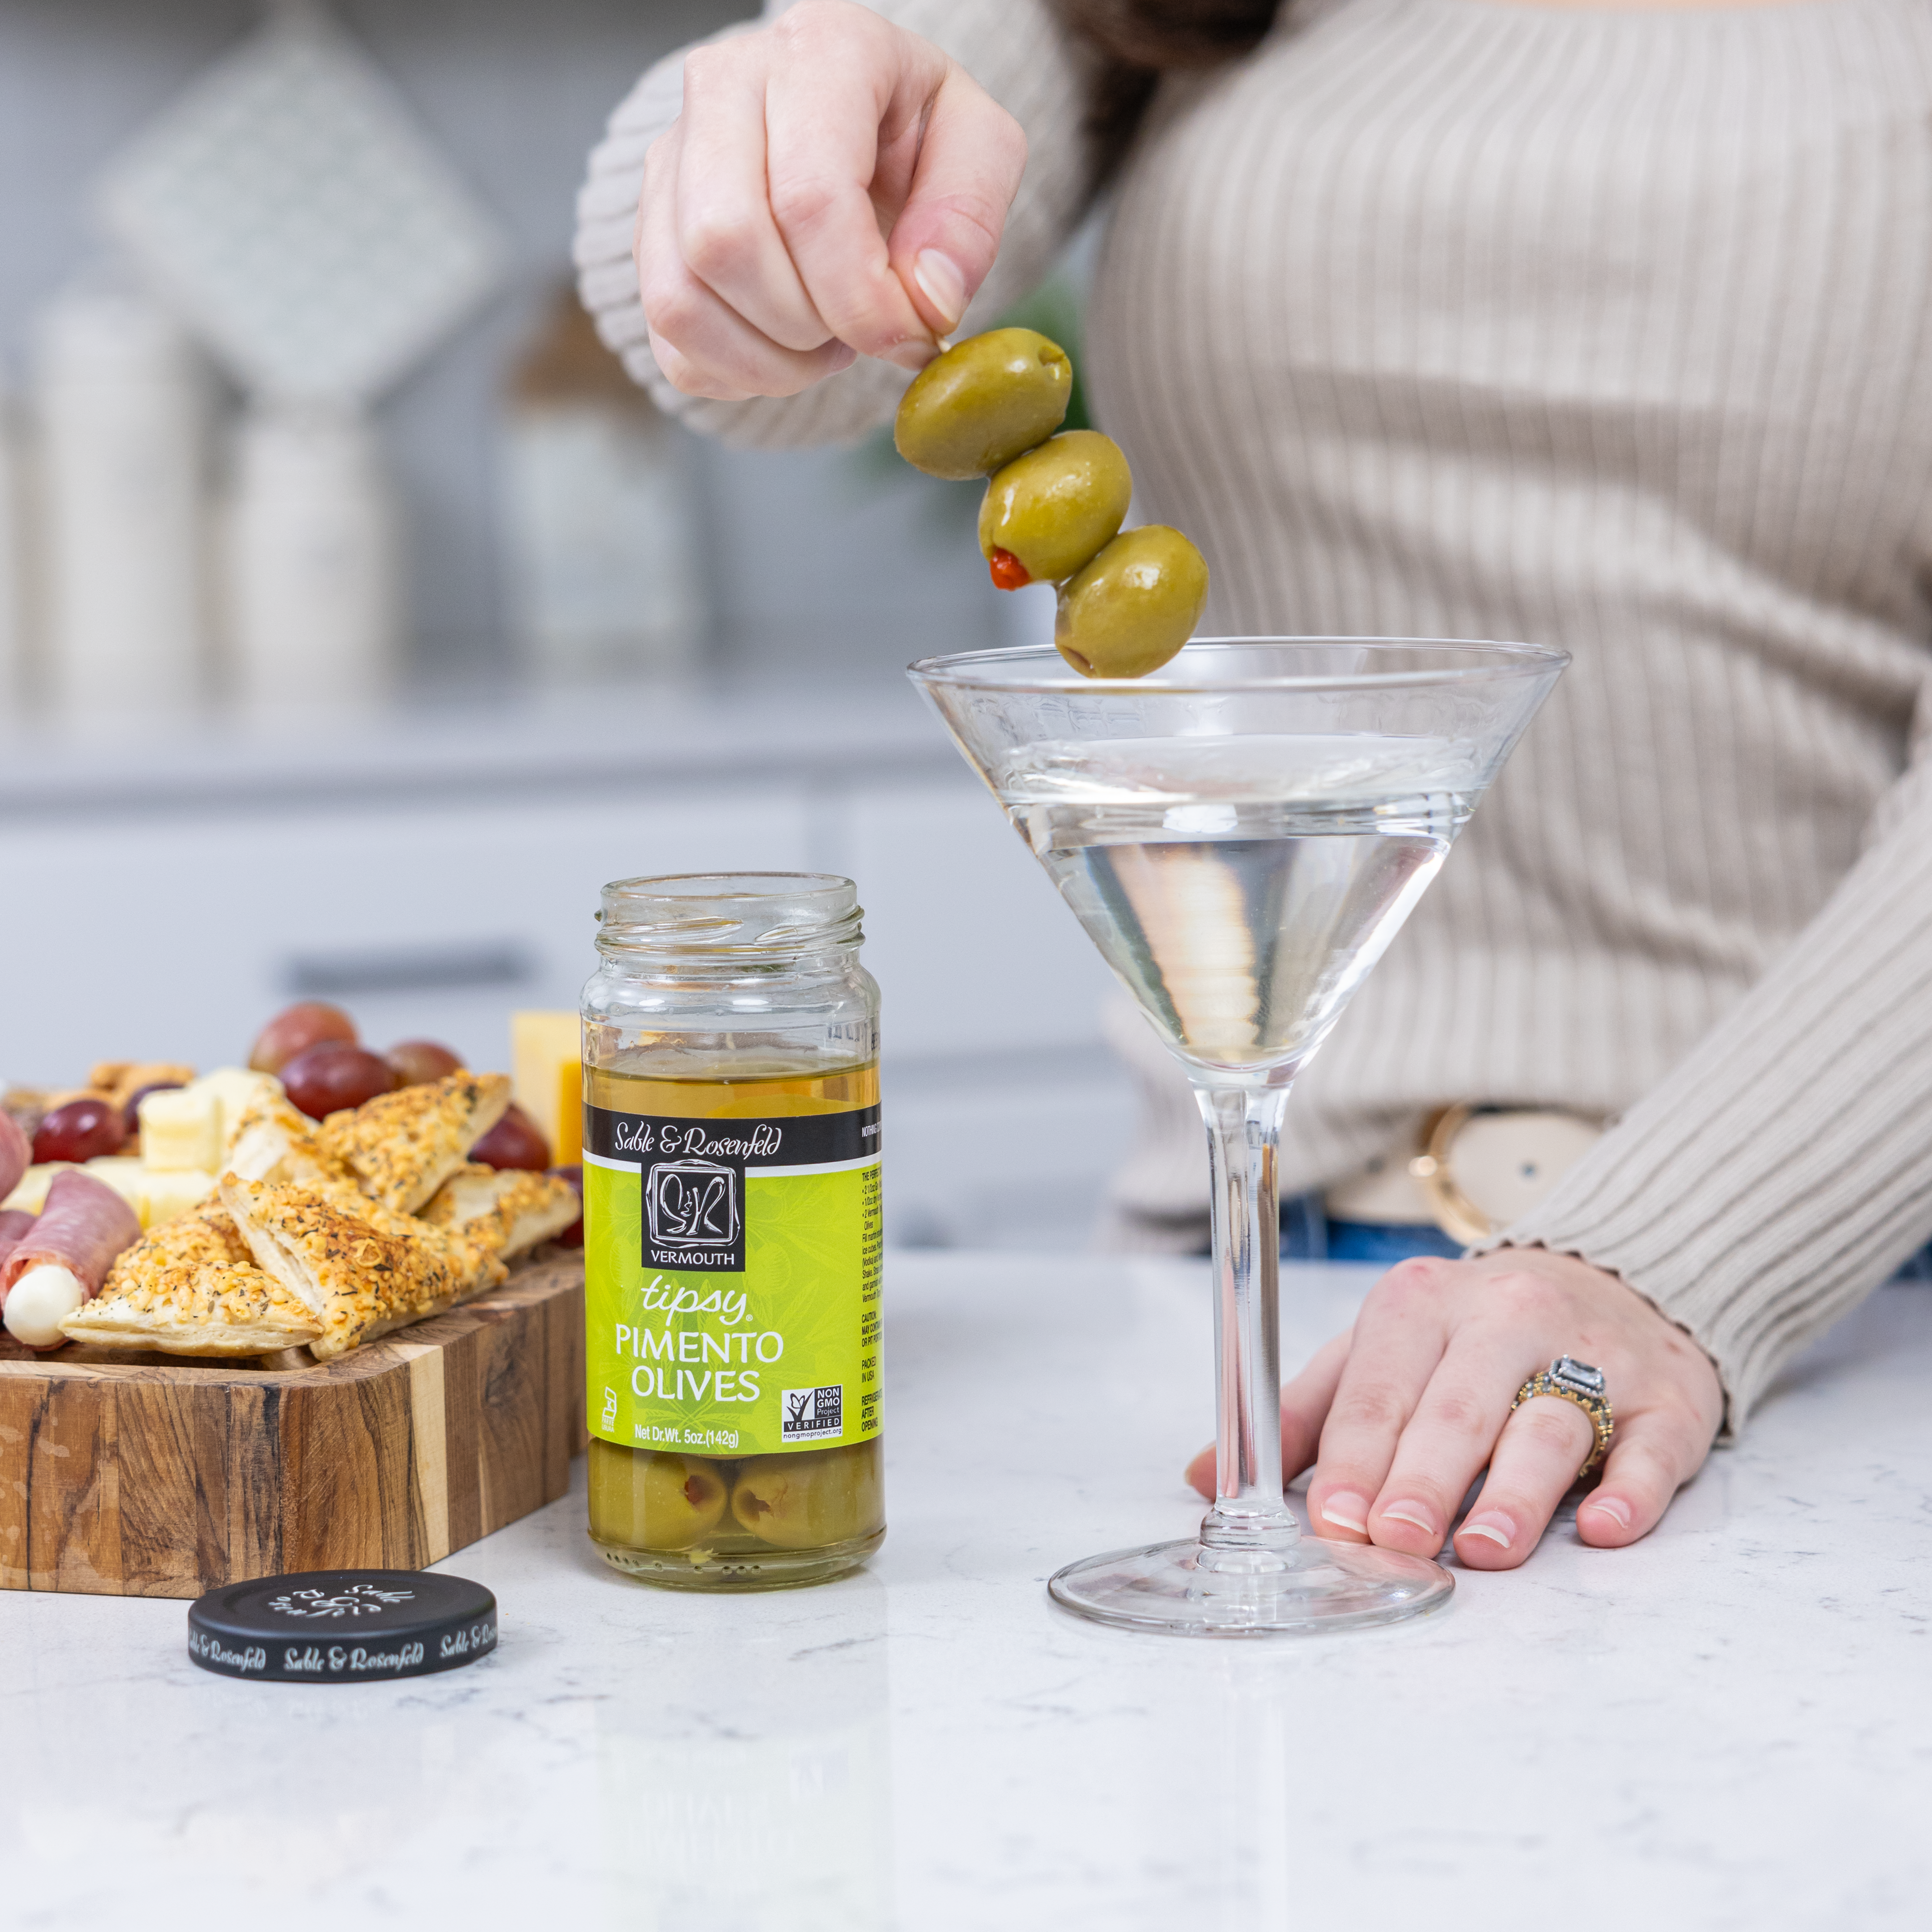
583;873;885;1590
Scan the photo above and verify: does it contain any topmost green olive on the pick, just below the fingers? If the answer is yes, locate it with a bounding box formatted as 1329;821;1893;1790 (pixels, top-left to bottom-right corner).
893;328;1074;483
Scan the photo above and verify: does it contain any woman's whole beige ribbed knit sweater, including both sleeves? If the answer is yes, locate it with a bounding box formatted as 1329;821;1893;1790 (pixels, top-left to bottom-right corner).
578;0;1932;1426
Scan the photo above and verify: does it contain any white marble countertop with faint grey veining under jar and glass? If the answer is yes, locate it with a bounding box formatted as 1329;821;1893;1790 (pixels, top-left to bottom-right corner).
0;1254;1932;1932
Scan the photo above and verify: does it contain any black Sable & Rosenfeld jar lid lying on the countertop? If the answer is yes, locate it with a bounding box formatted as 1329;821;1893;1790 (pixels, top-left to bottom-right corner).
187;1571;497;1685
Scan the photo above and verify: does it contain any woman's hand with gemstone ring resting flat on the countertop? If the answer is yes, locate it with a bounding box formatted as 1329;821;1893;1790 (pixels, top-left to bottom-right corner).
1188;1248;1723;1569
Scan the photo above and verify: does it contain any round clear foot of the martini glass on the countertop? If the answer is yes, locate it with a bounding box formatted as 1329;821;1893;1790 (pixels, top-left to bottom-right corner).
1047;1536;1455;1636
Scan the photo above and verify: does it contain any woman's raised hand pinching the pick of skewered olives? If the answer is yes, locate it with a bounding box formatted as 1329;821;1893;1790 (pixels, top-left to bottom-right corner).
636;0;1026;402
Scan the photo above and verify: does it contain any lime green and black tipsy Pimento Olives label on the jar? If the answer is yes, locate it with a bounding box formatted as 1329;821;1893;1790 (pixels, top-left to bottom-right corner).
583;1107;883;1457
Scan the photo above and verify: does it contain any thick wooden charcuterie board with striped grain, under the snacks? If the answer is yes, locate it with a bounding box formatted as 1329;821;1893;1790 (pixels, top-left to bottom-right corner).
0;1256;583;1596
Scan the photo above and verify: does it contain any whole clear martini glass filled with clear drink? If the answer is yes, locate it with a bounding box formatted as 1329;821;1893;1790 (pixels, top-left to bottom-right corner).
910;638;1569;1636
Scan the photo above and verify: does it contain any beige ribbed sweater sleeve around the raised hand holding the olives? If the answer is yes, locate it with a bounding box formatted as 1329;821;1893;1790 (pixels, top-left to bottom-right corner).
574;0;1094;448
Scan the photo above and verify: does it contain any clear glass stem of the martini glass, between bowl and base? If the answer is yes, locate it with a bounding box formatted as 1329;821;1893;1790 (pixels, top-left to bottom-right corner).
1194;1082;1300;1569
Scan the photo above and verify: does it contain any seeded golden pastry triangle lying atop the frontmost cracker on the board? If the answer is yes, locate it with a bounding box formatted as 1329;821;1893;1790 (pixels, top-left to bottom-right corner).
220;1175;506;1362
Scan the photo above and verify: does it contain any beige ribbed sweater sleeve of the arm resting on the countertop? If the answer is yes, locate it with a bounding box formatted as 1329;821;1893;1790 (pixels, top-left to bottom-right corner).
1482;697;1932;1434
